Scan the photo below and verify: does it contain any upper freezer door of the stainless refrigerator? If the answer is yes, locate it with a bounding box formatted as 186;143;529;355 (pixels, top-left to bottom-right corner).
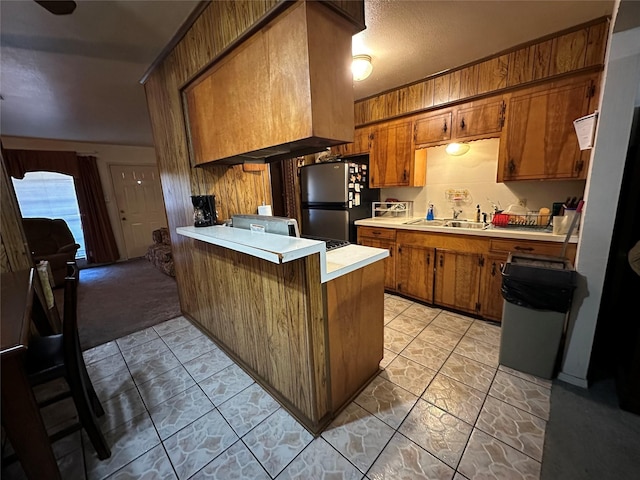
300;162;349;204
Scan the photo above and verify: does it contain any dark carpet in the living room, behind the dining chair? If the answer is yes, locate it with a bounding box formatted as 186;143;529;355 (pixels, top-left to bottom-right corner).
54;258;181;350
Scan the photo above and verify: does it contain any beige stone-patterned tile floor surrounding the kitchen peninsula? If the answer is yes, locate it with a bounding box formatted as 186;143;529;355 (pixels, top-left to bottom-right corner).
2;294;551;480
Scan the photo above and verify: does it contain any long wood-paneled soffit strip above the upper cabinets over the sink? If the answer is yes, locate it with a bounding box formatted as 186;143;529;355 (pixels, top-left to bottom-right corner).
355;17;610;126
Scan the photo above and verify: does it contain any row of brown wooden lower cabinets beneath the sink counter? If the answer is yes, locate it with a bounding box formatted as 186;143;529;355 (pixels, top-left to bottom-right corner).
358;227;577;322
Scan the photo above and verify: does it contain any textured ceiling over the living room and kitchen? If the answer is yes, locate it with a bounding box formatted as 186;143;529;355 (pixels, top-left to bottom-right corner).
0;0;615;146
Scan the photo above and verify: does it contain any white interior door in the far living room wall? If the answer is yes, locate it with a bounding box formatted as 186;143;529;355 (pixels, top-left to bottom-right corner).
110;165;167;258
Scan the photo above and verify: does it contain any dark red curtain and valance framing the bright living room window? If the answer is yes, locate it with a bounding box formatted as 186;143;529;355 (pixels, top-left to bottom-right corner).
2;149;120;264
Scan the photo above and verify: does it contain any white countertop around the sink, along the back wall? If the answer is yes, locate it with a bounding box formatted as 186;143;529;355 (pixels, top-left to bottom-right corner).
355;217;578;243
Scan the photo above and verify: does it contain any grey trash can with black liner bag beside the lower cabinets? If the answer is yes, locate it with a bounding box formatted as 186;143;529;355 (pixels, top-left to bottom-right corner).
500;254;576;379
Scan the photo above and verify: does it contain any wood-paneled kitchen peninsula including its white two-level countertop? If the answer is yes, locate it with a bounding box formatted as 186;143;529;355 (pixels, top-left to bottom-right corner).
176;226;389;434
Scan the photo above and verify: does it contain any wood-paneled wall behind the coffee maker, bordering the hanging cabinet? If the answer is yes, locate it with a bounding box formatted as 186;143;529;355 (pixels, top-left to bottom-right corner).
144;0;282;313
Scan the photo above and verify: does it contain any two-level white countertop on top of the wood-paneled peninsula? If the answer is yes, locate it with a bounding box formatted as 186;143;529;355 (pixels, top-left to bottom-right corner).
176;225;389;283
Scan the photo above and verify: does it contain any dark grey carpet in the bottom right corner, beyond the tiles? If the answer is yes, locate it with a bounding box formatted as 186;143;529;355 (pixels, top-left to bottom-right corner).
540;379;640;480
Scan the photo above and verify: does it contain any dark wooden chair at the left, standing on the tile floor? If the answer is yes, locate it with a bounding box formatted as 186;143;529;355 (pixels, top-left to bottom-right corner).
26;262;111;460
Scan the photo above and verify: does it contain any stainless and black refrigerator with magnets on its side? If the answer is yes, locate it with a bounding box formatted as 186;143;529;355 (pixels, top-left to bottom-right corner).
300;155;380;243
